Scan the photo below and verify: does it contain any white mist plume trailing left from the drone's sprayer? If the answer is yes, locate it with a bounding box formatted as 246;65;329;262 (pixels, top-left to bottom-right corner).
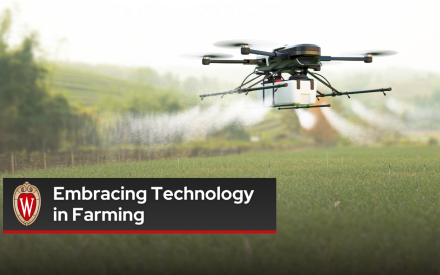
100;98;270;146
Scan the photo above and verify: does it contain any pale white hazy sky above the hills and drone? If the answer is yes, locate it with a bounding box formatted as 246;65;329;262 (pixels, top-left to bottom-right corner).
0;0;440;79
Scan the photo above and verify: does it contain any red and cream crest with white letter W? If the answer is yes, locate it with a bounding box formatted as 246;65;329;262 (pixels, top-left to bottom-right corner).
13;182;41;226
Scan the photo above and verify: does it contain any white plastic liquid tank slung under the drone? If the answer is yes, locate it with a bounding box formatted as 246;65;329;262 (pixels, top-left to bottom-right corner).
258;79;317;106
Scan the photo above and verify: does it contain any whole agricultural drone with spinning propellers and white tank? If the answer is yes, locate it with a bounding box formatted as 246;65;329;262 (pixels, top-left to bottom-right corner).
183;40;397;110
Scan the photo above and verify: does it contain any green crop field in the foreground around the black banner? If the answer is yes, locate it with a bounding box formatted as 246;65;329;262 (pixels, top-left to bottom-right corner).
0;146;440;274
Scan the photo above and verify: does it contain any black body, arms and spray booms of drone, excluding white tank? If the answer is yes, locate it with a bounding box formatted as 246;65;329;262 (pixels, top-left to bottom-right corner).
200;44;392;110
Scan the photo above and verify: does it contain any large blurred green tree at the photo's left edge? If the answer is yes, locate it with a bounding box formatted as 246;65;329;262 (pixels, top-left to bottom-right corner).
0;10;84;155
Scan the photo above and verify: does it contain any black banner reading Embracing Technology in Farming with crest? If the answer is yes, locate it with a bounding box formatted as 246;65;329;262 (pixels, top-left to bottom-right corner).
3;178;276;233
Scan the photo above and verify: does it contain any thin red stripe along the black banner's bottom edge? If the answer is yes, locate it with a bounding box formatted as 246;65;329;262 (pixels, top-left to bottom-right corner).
3;230;277;234
